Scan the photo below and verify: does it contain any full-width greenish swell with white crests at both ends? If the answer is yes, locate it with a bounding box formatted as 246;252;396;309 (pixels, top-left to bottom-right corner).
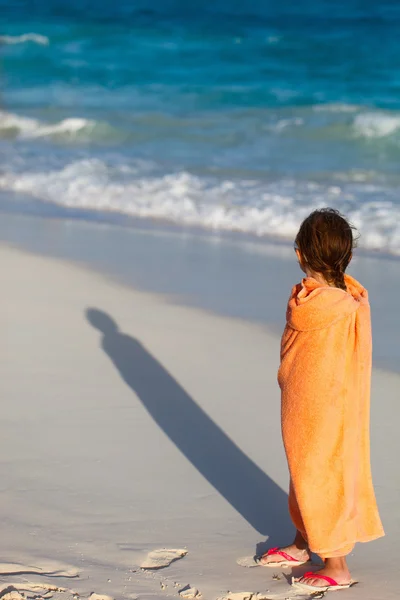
4;104;400;152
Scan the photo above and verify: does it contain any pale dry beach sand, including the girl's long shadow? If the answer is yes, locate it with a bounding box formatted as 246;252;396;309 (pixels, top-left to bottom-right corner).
0;247;400;600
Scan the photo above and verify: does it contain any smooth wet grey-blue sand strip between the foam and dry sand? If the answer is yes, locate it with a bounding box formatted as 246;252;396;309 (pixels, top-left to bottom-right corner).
0;209;400;373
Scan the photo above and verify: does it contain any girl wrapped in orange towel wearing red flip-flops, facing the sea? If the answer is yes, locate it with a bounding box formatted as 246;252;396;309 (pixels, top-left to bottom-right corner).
259;209;384;591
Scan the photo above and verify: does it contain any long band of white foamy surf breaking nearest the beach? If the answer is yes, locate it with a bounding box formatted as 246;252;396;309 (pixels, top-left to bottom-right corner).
0;159;400;255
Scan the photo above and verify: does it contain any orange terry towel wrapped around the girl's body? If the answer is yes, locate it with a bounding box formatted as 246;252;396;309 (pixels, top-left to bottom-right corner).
278;276;384;558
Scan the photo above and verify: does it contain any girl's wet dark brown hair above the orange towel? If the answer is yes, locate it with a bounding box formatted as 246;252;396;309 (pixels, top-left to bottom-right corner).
296;208;355;290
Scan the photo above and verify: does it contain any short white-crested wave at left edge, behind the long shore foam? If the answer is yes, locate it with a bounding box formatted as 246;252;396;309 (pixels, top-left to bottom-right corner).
0;111;125;141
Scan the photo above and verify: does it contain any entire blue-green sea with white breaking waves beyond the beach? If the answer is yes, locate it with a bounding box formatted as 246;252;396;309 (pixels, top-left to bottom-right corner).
0;0;400;255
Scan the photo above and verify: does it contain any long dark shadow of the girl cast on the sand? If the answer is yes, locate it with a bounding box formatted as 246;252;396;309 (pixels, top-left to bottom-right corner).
86;308;293;551
